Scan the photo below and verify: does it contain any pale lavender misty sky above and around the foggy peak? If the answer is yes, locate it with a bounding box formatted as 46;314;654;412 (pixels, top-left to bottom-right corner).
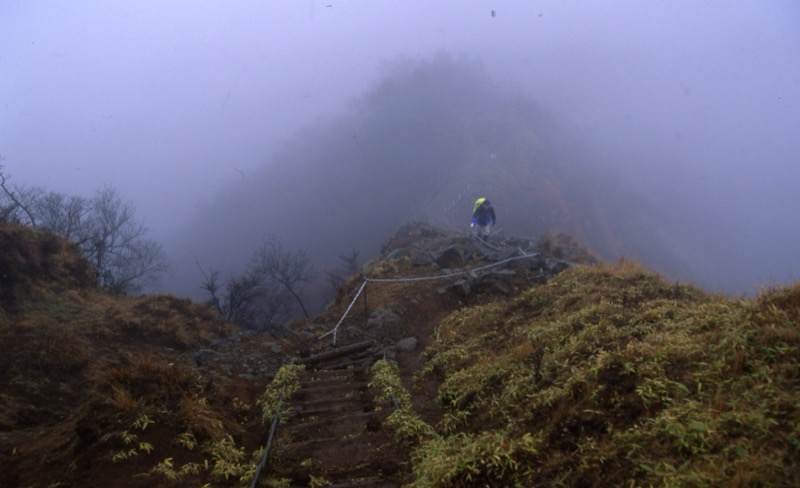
0;0;800;292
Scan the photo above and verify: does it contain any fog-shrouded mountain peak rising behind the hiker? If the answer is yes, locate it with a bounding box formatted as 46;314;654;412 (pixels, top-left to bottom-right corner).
176;55;691;310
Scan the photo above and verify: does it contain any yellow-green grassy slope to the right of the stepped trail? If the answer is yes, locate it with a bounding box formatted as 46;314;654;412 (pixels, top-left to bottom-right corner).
406;262;800;487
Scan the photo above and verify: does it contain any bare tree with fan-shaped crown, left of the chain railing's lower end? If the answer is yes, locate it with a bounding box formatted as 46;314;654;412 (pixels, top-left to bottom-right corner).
253;235;314;318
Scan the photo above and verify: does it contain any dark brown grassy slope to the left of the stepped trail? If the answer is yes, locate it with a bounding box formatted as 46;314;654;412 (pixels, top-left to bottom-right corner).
0;224;272;487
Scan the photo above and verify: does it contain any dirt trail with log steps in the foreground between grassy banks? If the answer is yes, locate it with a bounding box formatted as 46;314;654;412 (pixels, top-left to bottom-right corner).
262;342;408;488
